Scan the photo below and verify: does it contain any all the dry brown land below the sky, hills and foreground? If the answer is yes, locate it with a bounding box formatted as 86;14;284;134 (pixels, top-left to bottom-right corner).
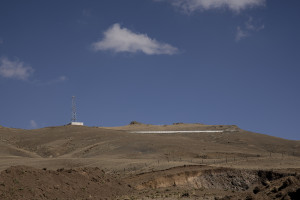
0;122;300;199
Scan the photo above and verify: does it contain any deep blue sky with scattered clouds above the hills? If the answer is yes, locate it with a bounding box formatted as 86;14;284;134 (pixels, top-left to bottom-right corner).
0;0;300;140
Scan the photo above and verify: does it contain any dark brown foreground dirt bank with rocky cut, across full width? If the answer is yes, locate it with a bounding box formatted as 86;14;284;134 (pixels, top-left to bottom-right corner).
0;166;300;200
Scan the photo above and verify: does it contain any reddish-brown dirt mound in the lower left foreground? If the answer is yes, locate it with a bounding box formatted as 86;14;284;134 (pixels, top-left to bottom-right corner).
0;166;132;200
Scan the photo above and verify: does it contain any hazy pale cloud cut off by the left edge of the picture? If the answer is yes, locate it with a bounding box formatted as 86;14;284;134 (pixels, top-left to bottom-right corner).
0;57;34;80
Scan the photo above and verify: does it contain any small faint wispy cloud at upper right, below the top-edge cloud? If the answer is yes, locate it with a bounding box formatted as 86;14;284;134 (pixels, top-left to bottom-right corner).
235;17;265;42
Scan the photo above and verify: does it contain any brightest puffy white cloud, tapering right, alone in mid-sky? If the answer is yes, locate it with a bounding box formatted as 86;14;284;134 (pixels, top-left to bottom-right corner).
92;24;178;55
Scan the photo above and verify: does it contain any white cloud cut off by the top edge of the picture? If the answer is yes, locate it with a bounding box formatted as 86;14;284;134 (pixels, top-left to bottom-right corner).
164;0;266;13
